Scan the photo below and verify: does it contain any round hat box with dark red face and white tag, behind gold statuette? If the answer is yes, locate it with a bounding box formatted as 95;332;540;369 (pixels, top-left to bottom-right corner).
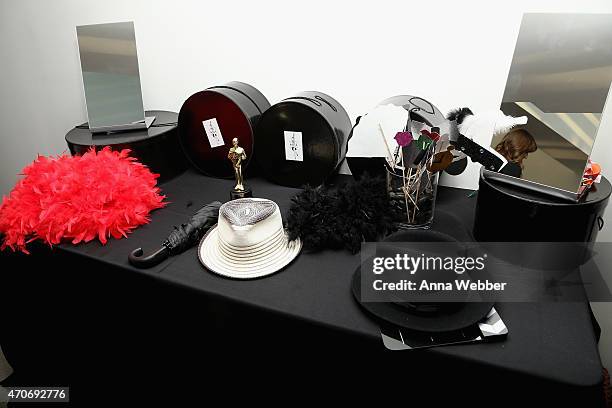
178;82;270;178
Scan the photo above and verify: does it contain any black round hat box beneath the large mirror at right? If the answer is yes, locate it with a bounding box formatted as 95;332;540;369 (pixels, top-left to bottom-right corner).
474;171;612;242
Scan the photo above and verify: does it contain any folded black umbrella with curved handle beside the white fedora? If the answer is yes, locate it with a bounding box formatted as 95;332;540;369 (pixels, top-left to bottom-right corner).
128;201;221;269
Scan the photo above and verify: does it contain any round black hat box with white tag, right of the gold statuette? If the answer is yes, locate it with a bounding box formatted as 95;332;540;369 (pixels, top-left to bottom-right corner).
255;91;351;187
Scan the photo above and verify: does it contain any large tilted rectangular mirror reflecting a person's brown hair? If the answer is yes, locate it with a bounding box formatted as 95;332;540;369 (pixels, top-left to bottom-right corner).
487;13;612;199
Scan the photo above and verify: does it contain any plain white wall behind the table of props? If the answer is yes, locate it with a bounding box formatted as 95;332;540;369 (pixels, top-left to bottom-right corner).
0;0;612;367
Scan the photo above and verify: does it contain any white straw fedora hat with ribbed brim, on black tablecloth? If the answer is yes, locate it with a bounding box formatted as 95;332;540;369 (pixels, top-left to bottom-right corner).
198;198;302;279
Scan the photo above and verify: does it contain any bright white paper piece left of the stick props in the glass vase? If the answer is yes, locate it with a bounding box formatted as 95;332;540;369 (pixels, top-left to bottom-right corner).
346;105;408;157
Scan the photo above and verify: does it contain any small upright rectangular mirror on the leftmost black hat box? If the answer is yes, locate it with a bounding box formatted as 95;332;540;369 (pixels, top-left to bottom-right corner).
76;22;145;132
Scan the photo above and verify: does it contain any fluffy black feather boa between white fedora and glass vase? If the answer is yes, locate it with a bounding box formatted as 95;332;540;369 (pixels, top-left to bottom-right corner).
287;175;394;253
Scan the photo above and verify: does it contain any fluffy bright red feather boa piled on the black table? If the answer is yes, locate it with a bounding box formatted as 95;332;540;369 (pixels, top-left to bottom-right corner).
0;147;166;253
